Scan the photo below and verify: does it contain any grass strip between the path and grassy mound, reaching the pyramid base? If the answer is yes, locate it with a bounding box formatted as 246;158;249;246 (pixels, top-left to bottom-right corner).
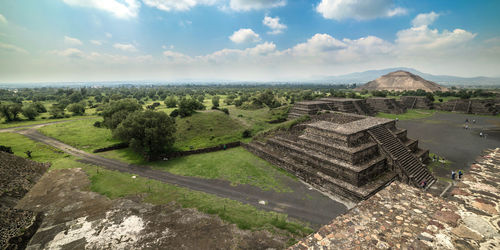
99;147;295;192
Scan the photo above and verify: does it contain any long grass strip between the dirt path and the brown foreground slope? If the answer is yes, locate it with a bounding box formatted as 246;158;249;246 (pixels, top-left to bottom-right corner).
0;133;313;238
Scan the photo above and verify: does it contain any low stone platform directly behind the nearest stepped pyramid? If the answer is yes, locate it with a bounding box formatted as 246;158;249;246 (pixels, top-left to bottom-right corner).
288;97;375;119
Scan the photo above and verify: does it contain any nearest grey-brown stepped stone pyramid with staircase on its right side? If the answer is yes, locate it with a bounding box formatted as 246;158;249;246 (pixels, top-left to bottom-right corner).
244;111;435;201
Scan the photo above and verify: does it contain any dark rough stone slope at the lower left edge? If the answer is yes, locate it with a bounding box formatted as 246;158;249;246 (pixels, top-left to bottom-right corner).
0;151;49;249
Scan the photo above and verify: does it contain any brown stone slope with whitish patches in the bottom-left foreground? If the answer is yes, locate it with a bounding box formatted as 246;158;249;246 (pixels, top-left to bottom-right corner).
18;169;286;249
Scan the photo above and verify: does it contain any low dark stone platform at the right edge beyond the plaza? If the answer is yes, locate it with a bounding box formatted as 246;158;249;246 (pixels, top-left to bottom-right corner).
435;99;500;115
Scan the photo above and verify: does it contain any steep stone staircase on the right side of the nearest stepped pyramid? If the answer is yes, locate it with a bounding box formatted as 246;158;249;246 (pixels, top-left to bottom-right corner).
368;126;436;188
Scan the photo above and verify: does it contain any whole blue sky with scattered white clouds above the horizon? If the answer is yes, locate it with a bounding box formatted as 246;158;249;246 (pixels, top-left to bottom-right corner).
0;0;500;83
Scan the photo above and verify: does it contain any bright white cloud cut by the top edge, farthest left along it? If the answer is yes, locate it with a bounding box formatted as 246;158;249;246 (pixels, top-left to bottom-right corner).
62;0;140;19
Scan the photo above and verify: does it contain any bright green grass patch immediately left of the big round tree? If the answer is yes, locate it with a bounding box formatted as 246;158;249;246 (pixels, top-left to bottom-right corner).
39;118;120;152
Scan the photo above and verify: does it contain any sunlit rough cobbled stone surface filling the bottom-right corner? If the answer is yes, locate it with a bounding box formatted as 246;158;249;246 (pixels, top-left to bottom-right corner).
291;148;500;249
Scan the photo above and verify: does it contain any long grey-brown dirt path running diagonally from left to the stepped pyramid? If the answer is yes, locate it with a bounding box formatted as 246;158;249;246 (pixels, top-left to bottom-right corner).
15;128;347;228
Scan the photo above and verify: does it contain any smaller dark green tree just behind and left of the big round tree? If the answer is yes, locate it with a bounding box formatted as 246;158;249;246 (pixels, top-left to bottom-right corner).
102;99;142;129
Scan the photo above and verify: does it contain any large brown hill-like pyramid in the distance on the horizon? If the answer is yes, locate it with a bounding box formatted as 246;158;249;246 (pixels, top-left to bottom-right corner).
359;70;448;92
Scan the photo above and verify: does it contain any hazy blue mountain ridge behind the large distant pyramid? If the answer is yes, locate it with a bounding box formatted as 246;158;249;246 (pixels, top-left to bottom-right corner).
322;67;500;86
